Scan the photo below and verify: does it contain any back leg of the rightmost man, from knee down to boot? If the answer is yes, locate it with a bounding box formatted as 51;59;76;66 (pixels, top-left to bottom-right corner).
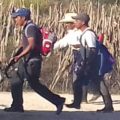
97;77;114;112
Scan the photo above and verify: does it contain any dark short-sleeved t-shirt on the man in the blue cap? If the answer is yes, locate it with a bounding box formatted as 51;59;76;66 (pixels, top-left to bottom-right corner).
22;21;42;59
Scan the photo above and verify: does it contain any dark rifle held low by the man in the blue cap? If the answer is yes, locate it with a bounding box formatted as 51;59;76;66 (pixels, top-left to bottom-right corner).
4;47;23;78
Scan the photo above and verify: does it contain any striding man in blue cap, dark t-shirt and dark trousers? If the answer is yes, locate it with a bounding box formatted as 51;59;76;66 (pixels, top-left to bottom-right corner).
4;8;65;115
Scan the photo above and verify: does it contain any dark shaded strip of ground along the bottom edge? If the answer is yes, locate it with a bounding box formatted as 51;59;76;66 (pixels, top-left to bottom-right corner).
0;110;120;120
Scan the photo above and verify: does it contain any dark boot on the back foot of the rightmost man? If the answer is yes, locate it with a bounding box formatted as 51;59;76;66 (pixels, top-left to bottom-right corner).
97;95;114;112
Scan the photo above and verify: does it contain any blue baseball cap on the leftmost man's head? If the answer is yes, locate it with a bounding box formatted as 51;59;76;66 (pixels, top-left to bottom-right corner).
11;8;31;18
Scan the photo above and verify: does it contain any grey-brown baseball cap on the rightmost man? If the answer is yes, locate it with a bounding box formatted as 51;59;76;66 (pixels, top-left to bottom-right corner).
72;13;90;23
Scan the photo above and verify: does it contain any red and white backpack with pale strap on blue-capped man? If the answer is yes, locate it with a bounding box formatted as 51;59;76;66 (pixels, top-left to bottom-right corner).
25;22;57;56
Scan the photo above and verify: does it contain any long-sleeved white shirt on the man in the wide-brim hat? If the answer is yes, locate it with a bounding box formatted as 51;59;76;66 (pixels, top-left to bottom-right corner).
53;29;82;50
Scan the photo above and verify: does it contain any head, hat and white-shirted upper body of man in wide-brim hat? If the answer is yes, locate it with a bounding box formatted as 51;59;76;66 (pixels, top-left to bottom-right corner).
53;13;81;50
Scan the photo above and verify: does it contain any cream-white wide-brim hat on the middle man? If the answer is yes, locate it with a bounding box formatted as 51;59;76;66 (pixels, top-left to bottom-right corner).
59;13;77;23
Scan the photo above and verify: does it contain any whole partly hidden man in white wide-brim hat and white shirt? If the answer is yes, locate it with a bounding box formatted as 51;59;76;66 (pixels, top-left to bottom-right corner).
53;13;87;103
